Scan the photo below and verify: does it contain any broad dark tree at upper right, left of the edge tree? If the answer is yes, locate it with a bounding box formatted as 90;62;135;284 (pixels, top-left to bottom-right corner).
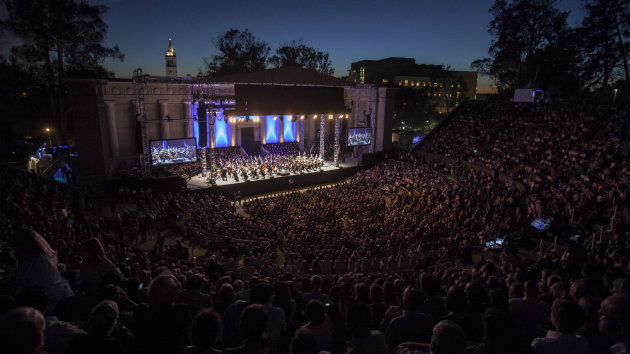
471;0;576;94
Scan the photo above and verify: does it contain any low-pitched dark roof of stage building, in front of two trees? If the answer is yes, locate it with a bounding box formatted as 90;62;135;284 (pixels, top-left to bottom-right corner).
210;67;354;86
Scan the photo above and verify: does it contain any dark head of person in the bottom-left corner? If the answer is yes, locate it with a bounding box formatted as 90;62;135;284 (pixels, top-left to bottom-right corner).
0;307;46;354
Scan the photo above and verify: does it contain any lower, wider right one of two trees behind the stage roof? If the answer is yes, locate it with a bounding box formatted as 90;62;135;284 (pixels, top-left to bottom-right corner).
269;41;335;75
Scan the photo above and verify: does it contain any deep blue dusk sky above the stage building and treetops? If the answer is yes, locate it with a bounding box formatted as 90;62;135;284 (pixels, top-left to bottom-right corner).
3;0;584;91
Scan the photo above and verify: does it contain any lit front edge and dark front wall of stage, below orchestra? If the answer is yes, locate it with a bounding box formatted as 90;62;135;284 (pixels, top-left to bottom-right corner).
186;158;358;197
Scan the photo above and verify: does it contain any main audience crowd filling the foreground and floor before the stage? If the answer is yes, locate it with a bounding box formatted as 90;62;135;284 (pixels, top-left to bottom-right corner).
0;100;630;354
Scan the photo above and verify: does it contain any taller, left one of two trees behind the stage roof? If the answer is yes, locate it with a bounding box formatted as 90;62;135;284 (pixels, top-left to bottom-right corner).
204;28;271;76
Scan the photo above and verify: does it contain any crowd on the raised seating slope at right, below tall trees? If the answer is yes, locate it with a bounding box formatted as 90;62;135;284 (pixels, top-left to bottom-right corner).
421;102;630;236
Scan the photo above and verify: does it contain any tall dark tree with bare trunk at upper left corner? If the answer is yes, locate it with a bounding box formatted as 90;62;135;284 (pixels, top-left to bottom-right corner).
0;0;124;143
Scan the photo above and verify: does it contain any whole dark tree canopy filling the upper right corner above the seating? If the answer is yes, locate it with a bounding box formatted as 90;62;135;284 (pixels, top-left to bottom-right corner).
471;0;630;101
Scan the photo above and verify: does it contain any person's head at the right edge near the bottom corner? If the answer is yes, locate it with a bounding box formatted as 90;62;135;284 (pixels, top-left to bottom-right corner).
599;294;630;343
